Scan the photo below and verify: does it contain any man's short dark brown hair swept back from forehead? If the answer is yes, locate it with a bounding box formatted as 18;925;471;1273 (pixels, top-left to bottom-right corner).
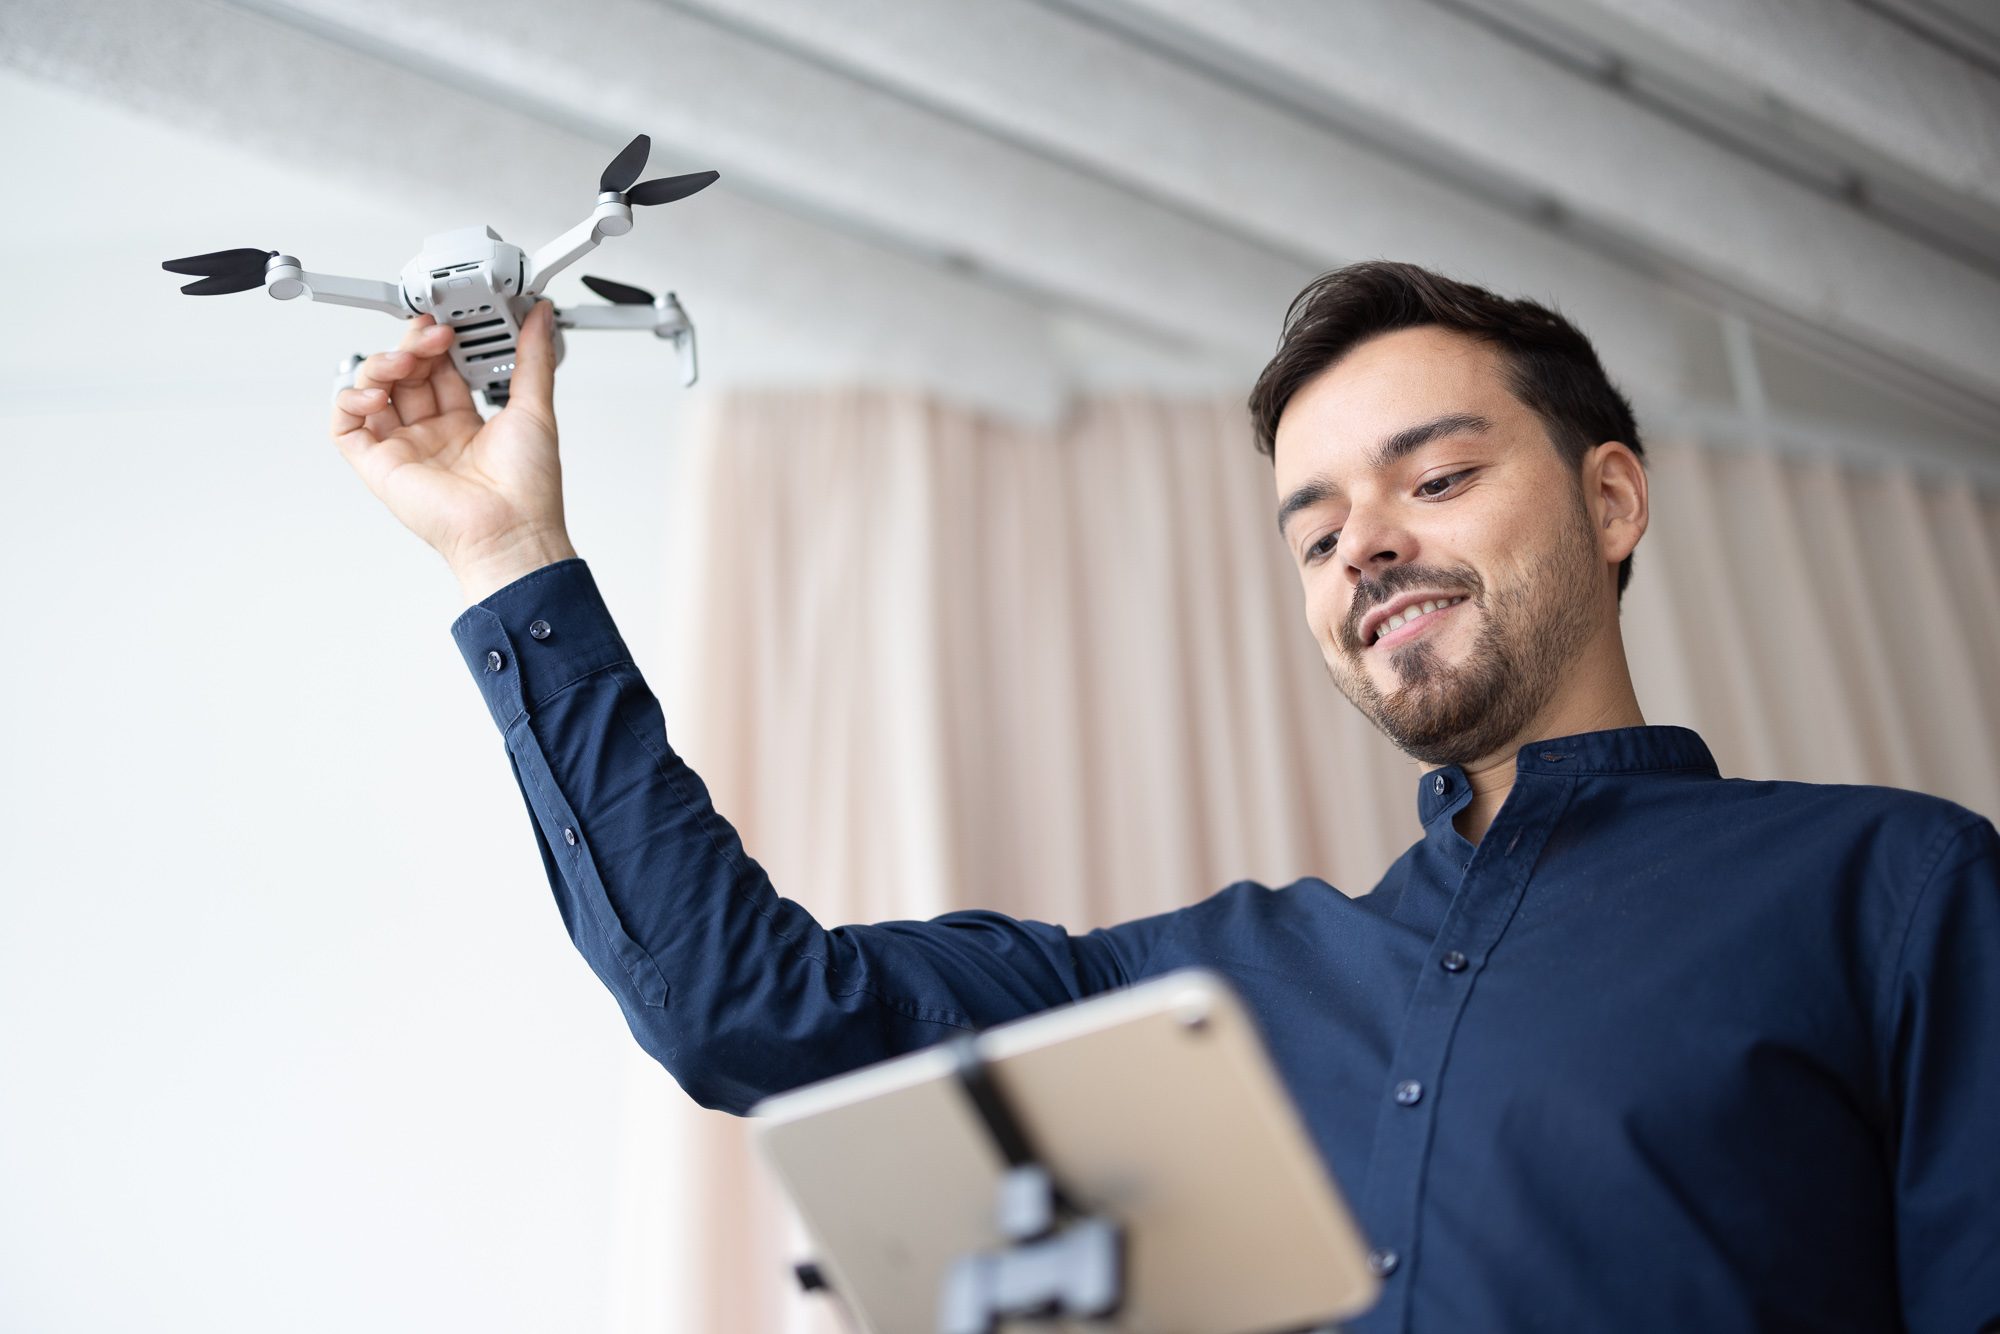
1250;260;1646;598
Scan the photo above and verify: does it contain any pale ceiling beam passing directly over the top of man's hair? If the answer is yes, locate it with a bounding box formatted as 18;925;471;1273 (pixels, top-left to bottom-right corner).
676;0;1720;398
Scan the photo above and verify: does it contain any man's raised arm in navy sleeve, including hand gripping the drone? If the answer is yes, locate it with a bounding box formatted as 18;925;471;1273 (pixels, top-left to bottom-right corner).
332;302;1164;1112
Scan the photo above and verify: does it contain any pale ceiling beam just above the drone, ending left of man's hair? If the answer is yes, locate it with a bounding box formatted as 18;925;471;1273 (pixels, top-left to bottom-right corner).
230;0;1310;370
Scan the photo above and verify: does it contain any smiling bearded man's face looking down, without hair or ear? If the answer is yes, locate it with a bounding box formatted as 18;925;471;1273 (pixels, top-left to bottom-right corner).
1276;326;1616;764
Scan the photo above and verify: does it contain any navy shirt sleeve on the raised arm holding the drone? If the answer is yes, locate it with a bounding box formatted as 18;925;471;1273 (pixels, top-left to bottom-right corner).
452;558;1170;1112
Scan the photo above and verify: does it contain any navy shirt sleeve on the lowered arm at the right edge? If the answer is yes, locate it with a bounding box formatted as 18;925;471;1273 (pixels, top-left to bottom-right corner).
1886;818;2000;1334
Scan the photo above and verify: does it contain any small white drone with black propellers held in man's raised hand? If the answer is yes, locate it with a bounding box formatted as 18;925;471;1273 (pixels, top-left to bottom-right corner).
160;134;718;408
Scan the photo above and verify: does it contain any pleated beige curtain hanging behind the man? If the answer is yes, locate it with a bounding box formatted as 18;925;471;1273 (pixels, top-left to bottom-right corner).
616;392;2000;1332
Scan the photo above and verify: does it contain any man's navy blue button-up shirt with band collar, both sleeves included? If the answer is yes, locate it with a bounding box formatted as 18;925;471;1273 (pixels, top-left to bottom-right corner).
452;560;2000;1334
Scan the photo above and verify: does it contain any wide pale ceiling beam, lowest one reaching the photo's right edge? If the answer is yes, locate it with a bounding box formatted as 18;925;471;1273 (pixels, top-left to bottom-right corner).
1072;0;2000;424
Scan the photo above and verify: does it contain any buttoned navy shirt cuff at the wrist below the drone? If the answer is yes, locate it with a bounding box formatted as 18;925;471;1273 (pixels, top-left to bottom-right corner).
452;556;632;732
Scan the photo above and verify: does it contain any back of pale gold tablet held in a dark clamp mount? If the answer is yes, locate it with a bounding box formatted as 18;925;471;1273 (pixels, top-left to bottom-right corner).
752;970;1378;1334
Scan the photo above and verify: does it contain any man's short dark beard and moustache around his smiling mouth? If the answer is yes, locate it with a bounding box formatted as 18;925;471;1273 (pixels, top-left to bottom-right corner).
1328;492;1604;764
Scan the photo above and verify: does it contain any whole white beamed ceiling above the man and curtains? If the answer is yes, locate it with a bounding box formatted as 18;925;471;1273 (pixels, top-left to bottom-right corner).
0;0;2000;458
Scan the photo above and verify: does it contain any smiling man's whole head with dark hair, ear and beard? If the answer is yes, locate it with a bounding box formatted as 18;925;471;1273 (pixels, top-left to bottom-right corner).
1250;262;1646;764
